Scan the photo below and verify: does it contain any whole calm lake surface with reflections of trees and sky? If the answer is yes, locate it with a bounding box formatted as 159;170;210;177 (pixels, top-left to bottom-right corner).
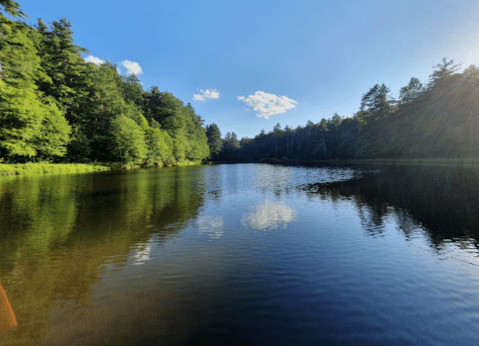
0;164;479;345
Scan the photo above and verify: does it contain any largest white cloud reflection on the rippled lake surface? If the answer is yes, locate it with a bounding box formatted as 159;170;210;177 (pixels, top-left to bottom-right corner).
241;201;297;230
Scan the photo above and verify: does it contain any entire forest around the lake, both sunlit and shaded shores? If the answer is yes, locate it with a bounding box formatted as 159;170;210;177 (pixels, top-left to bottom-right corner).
0;0;479;167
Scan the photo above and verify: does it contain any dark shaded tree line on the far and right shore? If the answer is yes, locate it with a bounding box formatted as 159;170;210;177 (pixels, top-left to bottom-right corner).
207;59;479;162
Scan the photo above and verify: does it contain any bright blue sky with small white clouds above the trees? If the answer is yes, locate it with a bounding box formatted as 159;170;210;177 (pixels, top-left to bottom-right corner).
11;0;479;138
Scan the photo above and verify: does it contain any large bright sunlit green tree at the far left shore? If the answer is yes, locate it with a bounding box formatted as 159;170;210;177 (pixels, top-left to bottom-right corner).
0;17;71;161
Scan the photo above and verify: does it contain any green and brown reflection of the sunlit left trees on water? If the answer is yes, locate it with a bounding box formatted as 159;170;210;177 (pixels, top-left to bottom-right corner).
0;167;204;344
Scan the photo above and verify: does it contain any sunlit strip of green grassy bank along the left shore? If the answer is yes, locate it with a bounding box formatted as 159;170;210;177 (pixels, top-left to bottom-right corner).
0;163;110;176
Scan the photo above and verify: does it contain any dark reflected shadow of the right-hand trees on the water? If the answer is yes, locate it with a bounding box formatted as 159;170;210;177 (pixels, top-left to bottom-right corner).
301;165;479;248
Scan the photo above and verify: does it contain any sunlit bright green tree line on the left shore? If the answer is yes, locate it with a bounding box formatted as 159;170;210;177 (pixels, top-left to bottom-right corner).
0;0;210;167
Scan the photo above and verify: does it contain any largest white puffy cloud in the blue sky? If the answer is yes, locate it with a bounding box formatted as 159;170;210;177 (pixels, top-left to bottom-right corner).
238;91;298;119
